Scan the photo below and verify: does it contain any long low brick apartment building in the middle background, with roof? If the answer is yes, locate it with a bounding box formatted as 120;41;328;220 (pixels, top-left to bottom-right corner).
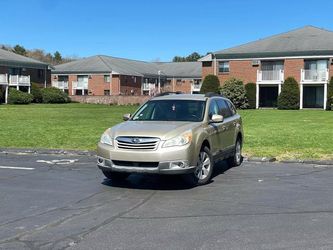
52;55;202;96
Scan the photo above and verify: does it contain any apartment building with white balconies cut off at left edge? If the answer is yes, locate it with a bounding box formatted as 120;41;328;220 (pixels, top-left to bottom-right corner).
0;49;51;103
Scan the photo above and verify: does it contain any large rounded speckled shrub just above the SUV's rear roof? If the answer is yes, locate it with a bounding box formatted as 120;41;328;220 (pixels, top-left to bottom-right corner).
220;78;249;109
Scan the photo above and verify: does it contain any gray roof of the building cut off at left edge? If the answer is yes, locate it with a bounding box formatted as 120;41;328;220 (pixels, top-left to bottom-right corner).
0;49;48;68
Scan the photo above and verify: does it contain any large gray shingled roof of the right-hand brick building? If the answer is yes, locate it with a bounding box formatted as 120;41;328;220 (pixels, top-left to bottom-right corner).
214;26;333;59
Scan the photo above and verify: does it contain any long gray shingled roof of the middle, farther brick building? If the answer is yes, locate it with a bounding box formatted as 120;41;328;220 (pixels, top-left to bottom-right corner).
52;55;201;78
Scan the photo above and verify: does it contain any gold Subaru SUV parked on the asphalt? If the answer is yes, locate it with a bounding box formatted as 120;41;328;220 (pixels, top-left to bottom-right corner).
97;93;243;185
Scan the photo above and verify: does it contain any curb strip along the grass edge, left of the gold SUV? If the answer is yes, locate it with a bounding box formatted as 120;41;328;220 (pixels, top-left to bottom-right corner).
0;148;96;156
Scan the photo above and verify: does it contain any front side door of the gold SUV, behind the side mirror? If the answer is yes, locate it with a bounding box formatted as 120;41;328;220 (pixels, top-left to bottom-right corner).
207;99;223;156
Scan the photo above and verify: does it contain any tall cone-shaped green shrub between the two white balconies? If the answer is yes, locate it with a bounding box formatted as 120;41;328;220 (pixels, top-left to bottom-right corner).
278;77;300;109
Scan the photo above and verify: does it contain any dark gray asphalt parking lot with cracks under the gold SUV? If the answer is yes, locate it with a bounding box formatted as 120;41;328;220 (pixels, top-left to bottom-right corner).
0;154;333;249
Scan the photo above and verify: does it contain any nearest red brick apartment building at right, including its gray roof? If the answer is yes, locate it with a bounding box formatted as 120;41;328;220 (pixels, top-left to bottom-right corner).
200;26;333;109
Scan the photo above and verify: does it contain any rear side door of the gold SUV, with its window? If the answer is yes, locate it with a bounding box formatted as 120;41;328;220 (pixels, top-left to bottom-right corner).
217;98;236;151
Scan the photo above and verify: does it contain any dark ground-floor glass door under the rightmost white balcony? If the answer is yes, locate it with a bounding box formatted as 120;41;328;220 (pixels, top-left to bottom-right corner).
303;85;324;108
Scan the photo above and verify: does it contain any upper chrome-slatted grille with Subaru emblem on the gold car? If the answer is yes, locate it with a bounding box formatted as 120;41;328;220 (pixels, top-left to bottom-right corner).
116;136;160;150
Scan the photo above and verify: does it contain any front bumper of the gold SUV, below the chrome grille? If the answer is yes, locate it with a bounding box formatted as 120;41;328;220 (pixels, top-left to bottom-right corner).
97;143;196;174
